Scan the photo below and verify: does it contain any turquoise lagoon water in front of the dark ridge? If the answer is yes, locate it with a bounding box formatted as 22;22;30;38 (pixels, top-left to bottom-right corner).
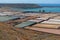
11;7;60;12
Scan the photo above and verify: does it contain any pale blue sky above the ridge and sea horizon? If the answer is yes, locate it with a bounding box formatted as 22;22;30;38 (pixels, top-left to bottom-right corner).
0;0;60;4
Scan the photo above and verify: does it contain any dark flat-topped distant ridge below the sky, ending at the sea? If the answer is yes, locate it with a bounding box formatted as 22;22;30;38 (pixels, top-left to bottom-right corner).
0;4;40;8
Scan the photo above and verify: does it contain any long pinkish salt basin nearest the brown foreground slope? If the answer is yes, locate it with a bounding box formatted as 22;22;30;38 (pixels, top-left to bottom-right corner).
25;27;60;35
